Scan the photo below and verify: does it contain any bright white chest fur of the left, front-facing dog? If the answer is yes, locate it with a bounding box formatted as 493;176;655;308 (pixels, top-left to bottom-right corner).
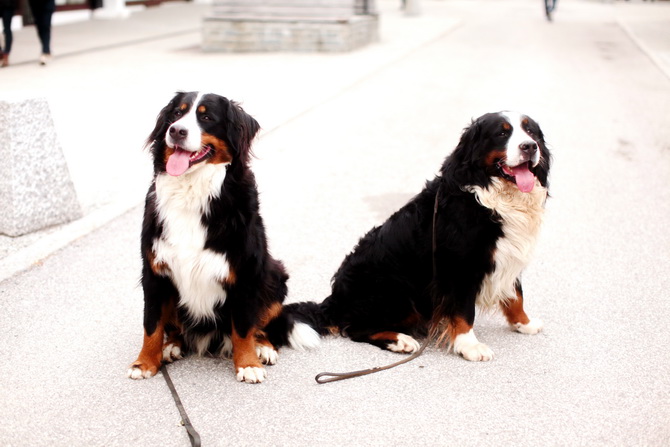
153;165;230;321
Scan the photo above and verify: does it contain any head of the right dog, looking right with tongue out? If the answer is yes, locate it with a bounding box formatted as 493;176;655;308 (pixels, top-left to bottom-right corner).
443;112;551;192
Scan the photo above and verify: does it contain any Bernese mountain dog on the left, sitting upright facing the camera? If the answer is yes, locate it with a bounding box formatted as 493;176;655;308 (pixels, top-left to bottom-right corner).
128;92;319;383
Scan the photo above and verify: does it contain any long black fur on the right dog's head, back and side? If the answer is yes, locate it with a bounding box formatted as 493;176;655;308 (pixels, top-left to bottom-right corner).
270;114;550;354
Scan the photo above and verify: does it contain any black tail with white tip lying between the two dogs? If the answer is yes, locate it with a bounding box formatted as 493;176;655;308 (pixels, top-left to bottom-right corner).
265;301;331;350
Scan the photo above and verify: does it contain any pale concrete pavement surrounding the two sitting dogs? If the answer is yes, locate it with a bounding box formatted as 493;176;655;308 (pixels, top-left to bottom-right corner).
0;0;670;446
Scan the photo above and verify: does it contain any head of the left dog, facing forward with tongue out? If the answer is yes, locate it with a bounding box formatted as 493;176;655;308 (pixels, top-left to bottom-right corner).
147;92;260;176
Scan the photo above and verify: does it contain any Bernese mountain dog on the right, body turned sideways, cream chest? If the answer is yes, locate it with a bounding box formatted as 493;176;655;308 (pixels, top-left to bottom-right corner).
284;112;550;361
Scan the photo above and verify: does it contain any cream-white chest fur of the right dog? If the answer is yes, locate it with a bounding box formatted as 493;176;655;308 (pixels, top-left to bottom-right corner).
470;179;547;307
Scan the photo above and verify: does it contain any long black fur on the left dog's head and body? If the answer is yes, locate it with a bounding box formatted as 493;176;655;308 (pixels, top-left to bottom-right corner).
141;92;288;368
